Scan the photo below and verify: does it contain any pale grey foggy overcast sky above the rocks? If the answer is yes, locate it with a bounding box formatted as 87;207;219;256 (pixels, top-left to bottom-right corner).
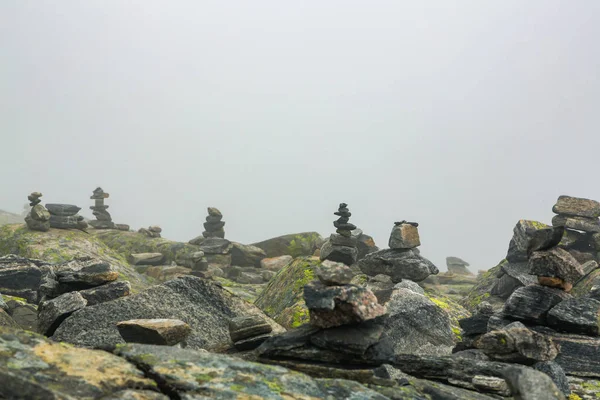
0;0;600;270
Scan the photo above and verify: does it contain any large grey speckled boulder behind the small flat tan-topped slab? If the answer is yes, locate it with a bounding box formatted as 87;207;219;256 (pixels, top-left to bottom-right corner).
53;276;283;349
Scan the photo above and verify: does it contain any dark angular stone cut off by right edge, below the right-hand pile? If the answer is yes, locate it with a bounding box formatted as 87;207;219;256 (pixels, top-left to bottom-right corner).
547;297;600;336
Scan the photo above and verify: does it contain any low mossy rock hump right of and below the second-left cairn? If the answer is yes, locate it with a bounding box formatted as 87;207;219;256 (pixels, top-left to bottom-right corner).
90;229;200;267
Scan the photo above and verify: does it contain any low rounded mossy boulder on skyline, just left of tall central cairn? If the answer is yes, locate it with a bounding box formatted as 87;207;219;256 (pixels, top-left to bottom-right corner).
252;232;324;258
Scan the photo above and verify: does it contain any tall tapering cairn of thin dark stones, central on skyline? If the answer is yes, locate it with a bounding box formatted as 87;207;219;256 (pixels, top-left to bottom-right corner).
320;203;358;265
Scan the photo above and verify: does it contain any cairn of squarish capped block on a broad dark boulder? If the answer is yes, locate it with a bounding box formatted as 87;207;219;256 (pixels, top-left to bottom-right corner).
358;221;439;283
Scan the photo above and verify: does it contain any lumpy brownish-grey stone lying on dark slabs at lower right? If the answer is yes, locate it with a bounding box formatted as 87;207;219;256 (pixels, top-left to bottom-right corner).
474;322;558;364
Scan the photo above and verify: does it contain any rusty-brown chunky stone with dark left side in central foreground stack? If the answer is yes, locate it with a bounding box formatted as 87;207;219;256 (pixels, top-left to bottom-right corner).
304;282;385;328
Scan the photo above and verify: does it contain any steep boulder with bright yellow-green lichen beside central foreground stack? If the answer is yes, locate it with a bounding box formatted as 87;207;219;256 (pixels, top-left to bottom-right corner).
254;257;321;329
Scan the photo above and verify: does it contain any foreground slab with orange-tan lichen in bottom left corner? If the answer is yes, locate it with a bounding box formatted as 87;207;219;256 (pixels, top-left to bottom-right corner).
0;328;156;400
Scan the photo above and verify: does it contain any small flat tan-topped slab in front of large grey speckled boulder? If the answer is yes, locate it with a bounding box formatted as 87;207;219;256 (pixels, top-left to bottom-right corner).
117;318;192;346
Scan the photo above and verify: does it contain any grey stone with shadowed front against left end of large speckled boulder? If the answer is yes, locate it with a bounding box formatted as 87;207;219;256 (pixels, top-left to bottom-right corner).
38;292;87;336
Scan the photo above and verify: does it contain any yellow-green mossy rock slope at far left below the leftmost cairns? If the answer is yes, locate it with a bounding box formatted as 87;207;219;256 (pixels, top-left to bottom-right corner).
0;224;153;292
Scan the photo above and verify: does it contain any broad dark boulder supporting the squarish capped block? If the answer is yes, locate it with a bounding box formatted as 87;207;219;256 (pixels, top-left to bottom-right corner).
358;249;439;283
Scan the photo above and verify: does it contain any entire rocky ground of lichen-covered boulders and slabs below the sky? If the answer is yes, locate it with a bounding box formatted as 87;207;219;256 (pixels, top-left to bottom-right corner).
0;198;600;400
